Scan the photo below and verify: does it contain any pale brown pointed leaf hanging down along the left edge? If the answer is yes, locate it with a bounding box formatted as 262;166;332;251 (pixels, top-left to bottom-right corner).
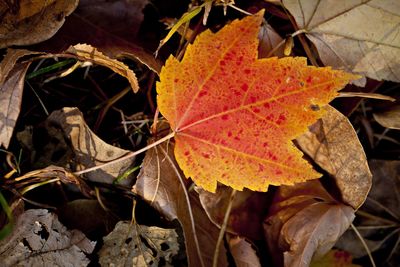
0;61;30;148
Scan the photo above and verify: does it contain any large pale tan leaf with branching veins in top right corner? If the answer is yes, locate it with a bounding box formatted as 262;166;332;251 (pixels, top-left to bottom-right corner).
283;0;400;82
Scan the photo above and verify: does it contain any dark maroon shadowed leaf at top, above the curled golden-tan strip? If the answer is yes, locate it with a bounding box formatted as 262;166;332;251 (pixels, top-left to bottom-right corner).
32;0;161;73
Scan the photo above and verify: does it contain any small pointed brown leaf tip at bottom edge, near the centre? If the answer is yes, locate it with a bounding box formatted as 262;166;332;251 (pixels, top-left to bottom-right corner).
227;235;261;267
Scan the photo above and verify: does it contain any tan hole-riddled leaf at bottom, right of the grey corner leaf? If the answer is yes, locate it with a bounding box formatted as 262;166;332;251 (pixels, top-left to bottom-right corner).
98;221;179;267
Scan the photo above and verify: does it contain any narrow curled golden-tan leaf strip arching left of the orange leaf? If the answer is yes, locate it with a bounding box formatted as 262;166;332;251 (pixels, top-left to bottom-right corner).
66;44;139;93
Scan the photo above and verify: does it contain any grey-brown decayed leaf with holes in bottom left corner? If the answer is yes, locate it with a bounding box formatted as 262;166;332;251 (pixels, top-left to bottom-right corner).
0;209;96;267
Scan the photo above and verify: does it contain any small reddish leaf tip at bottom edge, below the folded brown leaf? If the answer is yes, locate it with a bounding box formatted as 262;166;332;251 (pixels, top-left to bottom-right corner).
310;249;361;267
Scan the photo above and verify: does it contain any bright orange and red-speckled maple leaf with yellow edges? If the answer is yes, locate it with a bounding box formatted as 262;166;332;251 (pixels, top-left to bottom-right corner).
157;9;357;192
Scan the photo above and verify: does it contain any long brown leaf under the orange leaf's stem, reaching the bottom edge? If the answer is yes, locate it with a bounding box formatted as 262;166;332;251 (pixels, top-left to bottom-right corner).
133;143;228;267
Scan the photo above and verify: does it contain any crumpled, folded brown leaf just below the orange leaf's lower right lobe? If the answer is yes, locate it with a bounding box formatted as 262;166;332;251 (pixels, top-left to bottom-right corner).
264;180;355;267
